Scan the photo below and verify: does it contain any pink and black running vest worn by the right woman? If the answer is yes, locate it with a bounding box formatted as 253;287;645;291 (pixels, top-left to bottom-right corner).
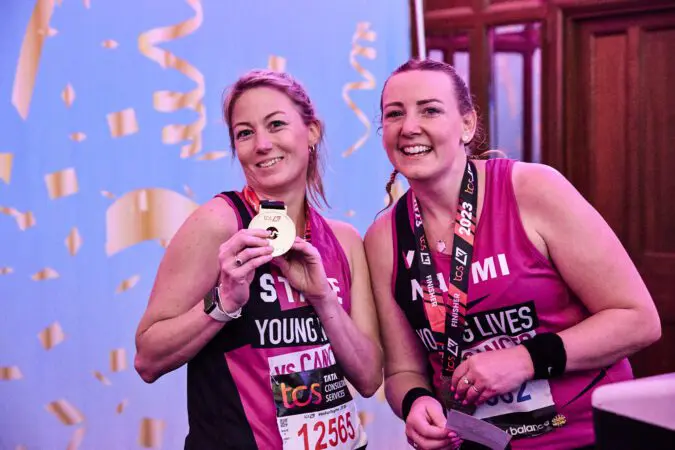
392;159;632;449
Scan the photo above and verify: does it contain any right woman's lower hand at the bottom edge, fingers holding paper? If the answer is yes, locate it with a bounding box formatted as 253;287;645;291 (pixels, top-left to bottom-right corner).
405;396;462;450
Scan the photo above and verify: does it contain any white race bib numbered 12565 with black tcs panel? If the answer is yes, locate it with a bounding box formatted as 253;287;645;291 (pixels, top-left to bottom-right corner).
269;344;366;450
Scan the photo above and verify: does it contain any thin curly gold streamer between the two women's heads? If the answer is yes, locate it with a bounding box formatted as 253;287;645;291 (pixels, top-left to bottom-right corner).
342;22;376;157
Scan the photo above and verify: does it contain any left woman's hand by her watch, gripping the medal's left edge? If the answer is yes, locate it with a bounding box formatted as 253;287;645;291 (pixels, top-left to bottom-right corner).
218;229;274;312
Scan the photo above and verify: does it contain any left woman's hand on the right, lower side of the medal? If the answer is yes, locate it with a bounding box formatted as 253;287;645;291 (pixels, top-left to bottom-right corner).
272;237;333;306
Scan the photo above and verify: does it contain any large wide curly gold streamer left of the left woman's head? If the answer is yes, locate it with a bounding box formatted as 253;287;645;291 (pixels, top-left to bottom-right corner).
138;0;206;158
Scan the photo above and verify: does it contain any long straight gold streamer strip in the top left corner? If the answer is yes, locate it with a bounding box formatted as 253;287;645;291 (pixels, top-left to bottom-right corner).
12;0;54;120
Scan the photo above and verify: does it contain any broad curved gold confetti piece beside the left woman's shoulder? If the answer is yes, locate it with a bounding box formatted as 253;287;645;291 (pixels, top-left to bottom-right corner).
106;188;199;256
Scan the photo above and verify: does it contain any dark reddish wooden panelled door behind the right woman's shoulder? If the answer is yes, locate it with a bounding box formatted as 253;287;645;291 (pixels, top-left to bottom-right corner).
559;8;675;376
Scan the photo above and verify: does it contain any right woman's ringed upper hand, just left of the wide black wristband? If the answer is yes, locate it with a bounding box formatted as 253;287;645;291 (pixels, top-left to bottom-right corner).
452;345;534;405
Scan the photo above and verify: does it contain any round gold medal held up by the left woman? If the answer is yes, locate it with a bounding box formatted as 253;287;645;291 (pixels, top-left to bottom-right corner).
248;200;295;256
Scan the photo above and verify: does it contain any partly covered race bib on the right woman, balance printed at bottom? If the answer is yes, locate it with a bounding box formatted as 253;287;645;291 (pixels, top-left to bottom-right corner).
463;332;565;438
